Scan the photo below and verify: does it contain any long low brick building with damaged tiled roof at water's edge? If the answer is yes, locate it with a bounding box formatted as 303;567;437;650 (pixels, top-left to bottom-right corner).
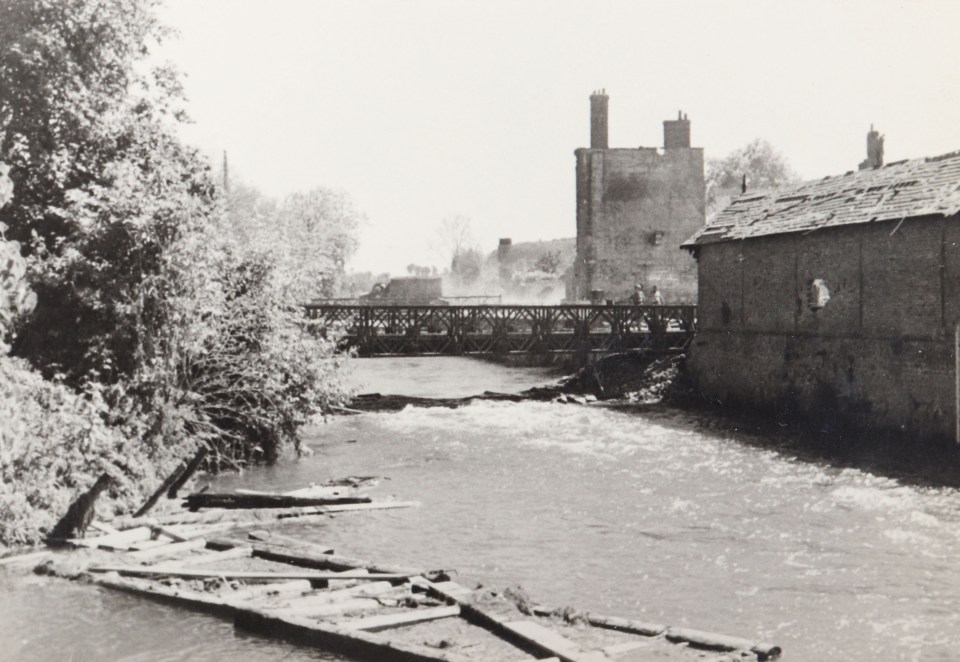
684;140;960;438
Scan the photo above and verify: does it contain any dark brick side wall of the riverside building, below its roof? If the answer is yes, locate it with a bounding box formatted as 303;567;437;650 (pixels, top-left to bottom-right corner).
689;217;960;438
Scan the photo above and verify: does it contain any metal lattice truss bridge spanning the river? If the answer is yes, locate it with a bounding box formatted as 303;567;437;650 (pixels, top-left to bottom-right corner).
306;303;697;356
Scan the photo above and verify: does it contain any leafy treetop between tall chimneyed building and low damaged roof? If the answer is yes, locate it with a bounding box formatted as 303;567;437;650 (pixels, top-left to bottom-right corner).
706;138;798;222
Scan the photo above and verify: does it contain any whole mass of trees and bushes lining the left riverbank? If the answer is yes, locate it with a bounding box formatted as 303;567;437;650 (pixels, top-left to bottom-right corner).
0;0;358;542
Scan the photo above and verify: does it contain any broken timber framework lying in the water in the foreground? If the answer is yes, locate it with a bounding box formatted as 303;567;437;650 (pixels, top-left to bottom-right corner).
41;524;780;662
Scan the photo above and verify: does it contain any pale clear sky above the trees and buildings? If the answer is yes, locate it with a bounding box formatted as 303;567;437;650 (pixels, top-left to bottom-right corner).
159;0;960;275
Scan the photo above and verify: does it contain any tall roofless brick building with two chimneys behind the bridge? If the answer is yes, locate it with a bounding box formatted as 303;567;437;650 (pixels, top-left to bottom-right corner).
567;92;704;303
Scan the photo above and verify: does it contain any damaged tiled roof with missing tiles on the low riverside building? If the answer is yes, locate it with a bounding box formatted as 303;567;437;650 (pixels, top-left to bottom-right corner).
682;151;960;249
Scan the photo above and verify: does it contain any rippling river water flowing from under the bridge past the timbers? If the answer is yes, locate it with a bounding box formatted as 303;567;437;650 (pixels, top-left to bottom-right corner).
0;358;960;661
